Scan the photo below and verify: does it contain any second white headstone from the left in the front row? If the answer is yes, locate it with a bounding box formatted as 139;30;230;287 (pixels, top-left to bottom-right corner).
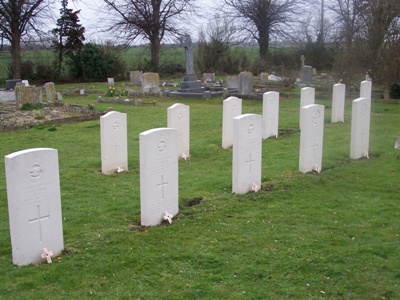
139;128;179;226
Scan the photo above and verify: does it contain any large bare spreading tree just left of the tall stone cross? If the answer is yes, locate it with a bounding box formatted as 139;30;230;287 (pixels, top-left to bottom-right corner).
104;0;195;72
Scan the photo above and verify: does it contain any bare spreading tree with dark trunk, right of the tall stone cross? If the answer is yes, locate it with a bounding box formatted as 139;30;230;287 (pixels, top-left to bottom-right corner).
224;0;301;60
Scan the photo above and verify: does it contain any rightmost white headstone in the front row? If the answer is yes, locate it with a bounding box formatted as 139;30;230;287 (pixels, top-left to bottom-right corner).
350;98;371;159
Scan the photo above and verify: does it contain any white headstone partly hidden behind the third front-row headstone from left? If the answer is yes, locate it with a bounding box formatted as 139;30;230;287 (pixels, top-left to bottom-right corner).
222;96;242;149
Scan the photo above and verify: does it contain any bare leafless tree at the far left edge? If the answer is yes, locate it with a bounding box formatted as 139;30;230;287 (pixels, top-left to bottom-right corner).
0;0;50;78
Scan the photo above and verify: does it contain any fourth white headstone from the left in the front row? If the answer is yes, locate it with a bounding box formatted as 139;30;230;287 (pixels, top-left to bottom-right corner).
299;104;325;173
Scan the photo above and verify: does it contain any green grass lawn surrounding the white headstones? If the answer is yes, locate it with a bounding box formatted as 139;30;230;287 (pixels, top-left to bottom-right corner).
0;84;400;299
